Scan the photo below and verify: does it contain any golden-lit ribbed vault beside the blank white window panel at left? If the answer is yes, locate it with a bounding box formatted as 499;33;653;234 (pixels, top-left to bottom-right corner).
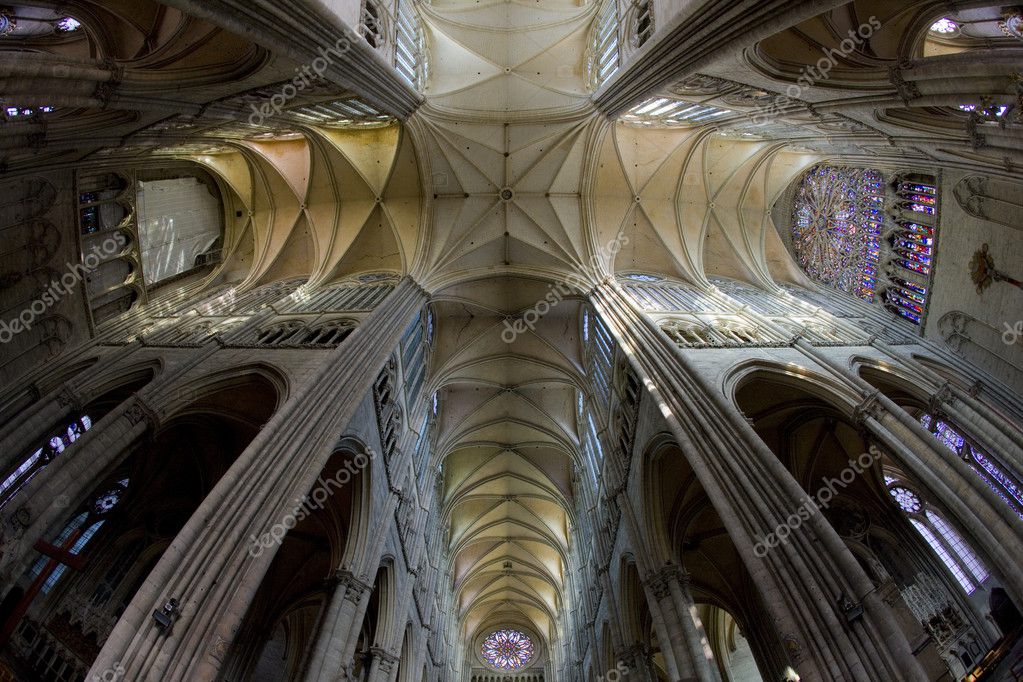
178;125;421;287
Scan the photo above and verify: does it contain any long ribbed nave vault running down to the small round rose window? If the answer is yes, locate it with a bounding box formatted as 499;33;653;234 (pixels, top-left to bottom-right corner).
433;277;582;662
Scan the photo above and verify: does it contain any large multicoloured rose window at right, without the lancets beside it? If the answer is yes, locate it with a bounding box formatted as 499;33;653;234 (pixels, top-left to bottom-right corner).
792;166;885;301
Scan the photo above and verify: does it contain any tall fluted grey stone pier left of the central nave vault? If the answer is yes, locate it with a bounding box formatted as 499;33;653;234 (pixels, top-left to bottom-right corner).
85;278;426;682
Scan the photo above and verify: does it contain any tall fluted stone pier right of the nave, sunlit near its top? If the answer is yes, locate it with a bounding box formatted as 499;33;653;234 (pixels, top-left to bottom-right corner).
590;278;926;682
